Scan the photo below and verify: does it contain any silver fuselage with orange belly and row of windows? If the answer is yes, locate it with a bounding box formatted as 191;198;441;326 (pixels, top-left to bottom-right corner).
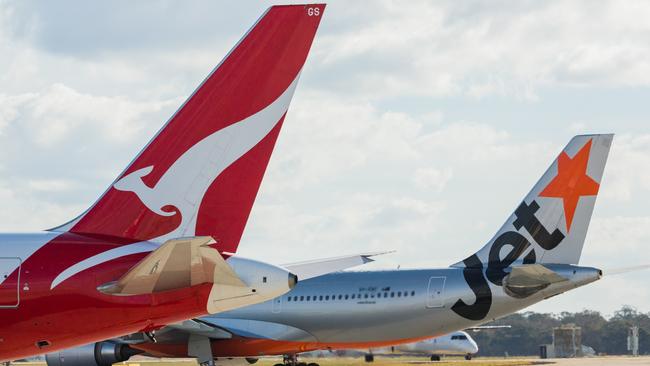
137;265;601;357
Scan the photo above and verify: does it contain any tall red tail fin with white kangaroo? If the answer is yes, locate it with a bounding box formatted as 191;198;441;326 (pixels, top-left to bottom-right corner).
52;4;325;252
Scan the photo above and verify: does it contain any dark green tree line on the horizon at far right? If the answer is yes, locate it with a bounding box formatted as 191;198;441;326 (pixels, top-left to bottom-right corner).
471;306;650;356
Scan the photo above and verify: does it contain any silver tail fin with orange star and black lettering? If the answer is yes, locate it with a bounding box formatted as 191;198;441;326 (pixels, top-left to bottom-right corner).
454;134;614;268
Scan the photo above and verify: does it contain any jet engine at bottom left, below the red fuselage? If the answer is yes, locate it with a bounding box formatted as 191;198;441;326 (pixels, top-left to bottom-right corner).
45;342;141;366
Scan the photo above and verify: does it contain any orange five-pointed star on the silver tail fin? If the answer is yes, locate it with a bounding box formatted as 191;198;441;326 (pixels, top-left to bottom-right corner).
539;139;600;231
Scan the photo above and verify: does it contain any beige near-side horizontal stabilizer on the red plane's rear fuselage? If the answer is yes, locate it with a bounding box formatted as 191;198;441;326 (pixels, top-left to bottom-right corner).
97;236;248;295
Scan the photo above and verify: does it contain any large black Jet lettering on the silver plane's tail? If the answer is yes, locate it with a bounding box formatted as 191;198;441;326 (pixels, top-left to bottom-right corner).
451;200;564;320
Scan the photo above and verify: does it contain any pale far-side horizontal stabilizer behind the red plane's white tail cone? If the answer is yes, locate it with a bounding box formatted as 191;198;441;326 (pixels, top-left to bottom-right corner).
282;251;394;281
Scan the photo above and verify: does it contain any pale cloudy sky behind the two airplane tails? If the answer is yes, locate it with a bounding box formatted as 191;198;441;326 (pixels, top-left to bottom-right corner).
0;0;650;315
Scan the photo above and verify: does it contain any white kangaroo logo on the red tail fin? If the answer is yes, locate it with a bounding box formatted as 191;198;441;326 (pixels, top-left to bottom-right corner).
113;75;300;241
